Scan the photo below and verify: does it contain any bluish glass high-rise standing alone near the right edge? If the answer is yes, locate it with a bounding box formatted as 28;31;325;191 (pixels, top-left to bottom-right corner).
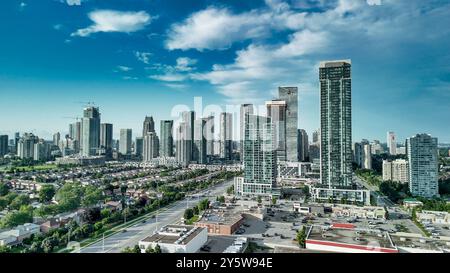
407;134;439;198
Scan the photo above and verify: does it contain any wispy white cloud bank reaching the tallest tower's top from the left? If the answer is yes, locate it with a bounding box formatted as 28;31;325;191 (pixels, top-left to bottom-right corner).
191;30;327;103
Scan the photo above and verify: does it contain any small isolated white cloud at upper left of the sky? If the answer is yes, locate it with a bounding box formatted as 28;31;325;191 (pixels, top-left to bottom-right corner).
71;10;152;37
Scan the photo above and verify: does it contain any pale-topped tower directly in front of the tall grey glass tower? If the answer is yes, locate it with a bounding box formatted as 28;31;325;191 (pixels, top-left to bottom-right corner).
266;100;286;161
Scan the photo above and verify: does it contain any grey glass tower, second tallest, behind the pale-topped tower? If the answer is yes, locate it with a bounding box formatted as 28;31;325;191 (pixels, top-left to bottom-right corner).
278;87;298;162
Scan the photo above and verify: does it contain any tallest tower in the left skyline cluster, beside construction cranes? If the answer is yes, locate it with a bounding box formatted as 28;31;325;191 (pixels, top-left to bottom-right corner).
81;107;100;156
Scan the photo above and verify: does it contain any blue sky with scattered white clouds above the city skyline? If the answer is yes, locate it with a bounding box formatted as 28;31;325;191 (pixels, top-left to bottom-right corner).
0;0;450;142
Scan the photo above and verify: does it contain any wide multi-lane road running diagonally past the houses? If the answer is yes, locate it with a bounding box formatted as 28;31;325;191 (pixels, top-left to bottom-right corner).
75;177;233;253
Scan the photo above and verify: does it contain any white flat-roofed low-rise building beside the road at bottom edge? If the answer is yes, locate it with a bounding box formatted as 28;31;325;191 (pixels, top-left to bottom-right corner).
139;225;208;253
